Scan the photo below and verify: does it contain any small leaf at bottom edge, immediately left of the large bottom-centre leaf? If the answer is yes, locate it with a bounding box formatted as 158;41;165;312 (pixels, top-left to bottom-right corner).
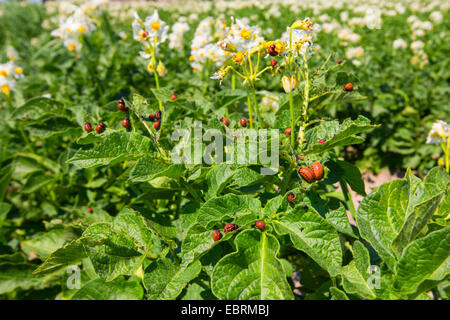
144;258;201;300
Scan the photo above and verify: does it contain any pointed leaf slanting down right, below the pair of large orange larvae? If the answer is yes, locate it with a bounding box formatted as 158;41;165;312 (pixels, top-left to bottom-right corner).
274;206;342;277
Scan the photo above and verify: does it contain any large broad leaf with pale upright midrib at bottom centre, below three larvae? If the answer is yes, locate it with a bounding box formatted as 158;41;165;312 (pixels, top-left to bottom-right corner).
211;229;293;300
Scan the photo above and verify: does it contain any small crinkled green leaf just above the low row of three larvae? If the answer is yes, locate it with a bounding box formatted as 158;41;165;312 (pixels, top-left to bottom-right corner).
197;194;262;228
